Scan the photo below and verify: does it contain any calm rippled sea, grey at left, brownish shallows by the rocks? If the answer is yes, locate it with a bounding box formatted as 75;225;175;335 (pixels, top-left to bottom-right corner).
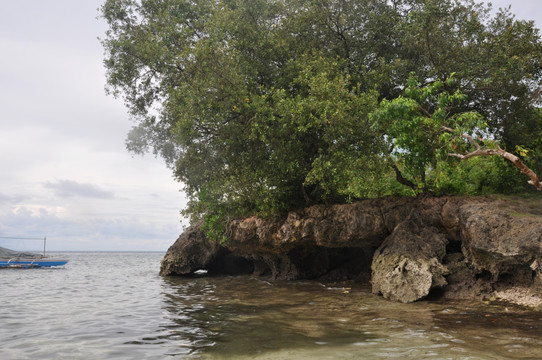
0;253;542;360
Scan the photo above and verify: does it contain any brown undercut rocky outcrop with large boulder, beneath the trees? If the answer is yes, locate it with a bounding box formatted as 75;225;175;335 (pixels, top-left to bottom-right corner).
161;197;542;303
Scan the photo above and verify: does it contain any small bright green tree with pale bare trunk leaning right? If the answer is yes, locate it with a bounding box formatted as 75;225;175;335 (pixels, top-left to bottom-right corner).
371;74;542;191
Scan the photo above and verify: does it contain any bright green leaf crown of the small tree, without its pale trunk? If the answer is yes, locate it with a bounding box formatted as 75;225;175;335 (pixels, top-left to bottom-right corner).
371;75;487;191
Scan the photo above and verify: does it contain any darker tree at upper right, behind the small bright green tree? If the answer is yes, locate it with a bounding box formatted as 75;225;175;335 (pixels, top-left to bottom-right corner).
400;0;542;165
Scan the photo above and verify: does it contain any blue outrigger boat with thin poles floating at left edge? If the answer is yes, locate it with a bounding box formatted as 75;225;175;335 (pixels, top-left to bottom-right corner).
0;238;69;269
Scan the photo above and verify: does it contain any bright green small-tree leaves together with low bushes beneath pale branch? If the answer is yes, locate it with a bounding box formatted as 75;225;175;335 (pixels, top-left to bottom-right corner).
371;74;542;195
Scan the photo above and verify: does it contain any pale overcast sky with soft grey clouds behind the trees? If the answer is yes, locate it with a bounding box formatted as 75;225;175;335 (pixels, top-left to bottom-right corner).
0;0;542;251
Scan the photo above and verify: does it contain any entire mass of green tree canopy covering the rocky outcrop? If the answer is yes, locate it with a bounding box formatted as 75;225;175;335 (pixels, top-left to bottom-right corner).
101;0;542;240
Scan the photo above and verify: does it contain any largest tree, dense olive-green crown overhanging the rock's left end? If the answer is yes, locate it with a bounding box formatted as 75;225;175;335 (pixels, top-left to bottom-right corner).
102;0;392;225
